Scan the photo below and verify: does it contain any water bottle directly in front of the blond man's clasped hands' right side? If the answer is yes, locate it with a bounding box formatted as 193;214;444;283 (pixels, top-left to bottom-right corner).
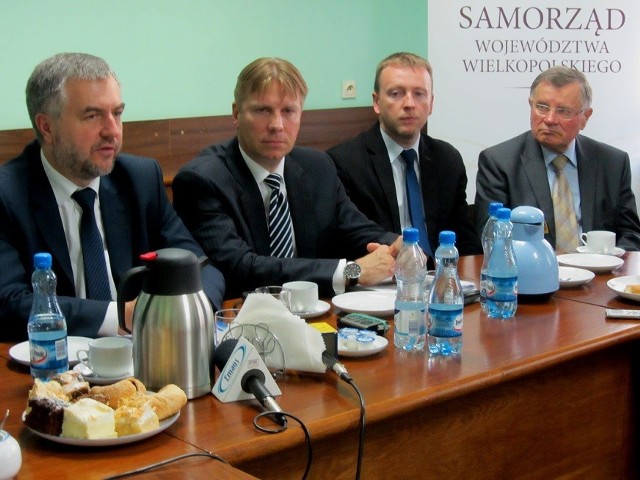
393;228;427;350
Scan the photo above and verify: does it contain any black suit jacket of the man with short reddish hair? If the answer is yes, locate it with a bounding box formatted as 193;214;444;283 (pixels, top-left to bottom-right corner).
327;123;481;255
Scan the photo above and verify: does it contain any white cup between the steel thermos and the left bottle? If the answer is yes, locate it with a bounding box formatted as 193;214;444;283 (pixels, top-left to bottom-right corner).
76;337;133;378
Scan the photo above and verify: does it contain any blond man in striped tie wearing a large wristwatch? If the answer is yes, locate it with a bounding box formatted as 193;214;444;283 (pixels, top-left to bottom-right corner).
172;58;398;297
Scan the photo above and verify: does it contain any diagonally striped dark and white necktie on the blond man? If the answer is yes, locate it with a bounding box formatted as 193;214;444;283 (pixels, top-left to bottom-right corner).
264;173;293;258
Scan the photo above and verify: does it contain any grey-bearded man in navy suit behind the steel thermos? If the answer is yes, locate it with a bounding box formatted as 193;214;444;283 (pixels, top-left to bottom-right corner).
0;54;224;340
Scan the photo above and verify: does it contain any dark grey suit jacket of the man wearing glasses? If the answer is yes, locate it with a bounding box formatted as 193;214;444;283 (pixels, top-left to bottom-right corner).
475;131;640;250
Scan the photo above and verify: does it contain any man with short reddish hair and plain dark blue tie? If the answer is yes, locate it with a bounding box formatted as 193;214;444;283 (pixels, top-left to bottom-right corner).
327;53;481;255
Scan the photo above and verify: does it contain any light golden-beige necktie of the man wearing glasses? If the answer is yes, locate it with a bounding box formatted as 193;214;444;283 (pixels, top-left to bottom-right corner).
551;155;578;253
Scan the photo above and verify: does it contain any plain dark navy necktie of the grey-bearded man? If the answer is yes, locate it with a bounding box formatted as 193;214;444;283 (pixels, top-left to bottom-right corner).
71;188;112;300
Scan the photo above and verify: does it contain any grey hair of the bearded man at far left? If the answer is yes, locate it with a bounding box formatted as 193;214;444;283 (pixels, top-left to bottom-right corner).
26;53;118;141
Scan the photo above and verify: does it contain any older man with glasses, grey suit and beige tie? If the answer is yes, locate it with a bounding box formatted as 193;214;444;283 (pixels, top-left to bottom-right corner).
475;66;640;253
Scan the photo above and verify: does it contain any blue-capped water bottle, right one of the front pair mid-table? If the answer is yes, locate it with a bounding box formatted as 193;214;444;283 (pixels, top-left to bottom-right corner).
427;230;464;356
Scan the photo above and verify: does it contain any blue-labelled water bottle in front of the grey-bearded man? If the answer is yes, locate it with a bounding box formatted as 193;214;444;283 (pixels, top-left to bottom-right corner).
27;253;69;380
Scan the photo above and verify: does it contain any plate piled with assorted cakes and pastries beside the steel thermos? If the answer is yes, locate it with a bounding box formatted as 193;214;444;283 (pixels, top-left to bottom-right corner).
22;371;187;447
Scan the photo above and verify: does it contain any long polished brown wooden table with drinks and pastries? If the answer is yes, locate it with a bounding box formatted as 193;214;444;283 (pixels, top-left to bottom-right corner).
0;253;640;479
